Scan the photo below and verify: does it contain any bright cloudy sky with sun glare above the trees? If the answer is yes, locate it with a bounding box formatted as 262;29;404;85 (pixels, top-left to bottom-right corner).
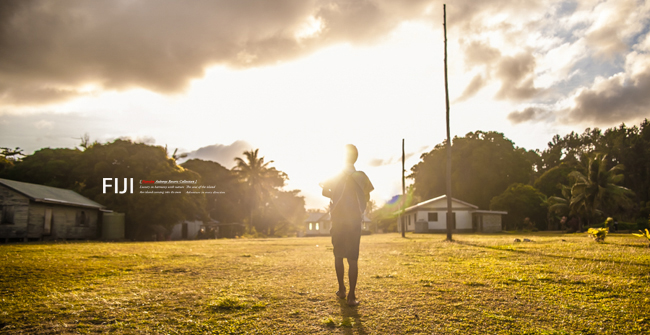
0;0;650;208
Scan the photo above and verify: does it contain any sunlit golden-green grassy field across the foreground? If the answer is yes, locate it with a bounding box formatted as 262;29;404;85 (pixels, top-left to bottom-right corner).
0;234;650;334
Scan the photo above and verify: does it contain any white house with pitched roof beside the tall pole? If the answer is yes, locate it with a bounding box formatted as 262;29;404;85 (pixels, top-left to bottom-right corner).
397;195;508;233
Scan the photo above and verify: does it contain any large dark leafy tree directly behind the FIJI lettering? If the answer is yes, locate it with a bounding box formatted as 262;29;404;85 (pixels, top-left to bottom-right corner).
78;140;207;238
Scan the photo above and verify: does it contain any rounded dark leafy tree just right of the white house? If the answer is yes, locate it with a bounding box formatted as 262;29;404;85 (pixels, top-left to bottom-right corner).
490;183;547;230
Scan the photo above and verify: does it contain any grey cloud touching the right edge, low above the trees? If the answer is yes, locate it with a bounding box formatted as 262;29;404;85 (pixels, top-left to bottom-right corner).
562;68;650;124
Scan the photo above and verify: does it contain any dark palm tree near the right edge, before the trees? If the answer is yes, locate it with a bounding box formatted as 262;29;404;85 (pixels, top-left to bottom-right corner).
569;153;634;228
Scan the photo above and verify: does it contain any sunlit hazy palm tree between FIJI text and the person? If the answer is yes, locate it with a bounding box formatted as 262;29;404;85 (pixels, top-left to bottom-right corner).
233;149;287;231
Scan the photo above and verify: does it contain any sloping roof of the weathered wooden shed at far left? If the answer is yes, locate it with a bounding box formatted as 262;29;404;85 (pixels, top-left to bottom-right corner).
0;178;104;208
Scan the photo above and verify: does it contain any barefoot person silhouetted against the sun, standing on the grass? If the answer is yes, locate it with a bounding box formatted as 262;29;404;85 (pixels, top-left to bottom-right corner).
321;144;374;306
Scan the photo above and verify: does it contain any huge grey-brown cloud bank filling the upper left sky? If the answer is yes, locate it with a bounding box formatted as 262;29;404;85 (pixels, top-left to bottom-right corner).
0;0;431;104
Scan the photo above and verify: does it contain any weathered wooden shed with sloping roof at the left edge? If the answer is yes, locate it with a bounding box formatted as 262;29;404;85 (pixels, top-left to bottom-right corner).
0;179;105;242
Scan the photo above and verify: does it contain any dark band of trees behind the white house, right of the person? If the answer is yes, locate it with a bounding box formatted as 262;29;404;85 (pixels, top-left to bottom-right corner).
374;119;650;234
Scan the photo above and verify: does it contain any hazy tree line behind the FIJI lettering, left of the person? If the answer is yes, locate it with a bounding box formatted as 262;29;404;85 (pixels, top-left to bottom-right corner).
0;140;305;239
